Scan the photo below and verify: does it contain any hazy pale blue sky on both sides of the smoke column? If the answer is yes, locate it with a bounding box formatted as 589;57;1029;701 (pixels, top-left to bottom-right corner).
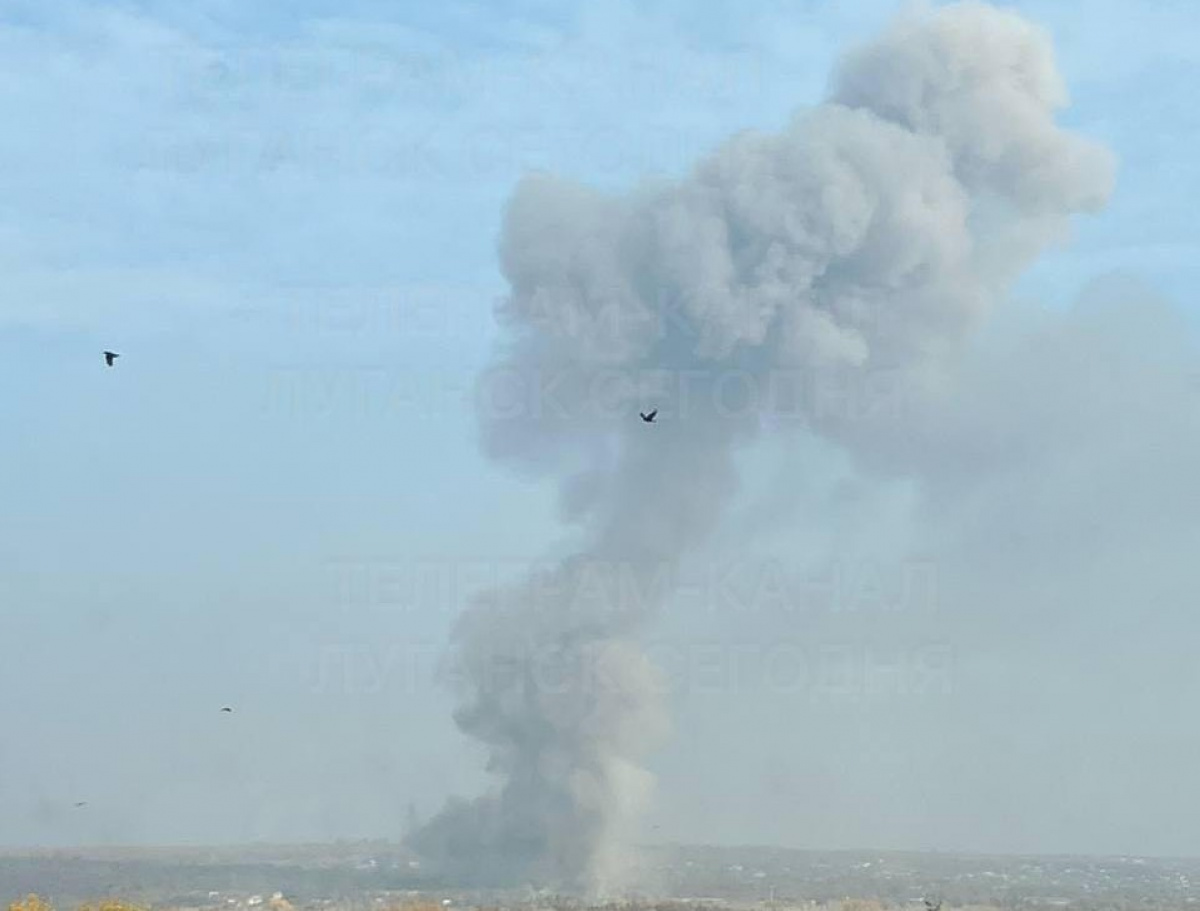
0;0;1200;853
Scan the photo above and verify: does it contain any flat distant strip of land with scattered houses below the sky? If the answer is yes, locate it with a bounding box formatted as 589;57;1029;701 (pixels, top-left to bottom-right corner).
0;843;1200;911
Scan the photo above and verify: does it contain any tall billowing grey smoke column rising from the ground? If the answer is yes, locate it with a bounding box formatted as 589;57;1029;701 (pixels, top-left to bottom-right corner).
414;2;1114;889
